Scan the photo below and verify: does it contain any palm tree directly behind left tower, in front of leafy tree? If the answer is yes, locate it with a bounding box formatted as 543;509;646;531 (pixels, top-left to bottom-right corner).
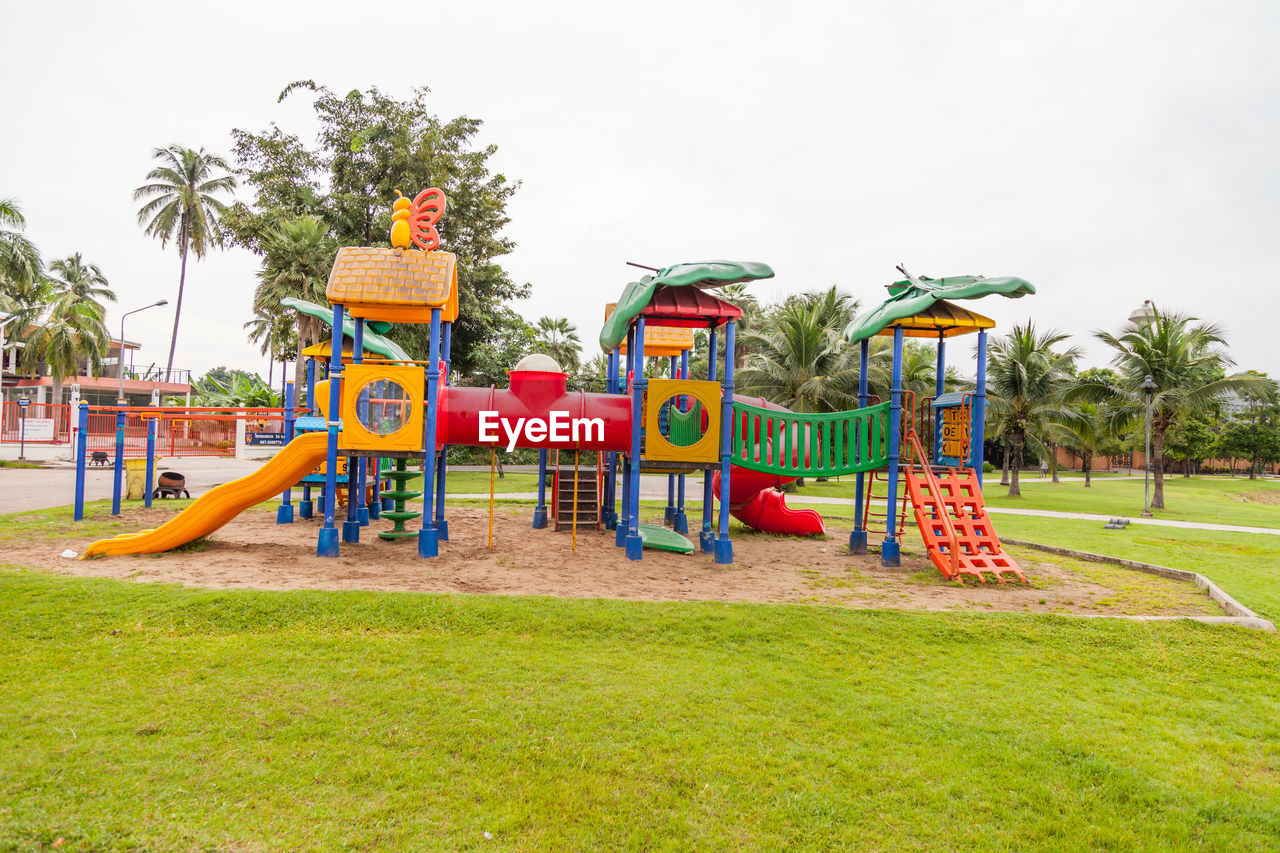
244;216;342;389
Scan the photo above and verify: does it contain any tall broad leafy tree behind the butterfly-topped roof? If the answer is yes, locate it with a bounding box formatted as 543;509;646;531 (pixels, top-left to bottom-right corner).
227;81;529;374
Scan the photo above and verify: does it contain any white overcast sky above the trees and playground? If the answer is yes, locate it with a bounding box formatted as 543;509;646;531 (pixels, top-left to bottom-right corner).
0;0;1280;375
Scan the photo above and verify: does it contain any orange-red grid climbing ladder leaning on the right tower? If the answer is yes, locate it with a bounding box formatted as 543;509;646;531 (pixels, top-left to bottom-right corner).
904;429;1027;583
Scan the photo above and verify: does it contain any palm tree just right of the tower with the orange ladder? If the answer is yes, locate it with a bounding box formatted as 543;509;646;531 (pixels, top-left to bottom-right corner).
975;320;1080;497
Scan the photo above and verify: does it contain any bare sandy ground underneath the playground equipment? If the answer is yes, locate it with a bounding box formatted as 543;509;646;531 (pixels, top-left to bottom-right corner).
12;507;1217;616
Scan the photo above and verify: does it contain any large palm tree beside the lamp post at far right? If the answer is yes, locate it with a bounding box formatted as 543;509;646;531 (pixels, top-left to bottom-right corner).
1073;306;1272;510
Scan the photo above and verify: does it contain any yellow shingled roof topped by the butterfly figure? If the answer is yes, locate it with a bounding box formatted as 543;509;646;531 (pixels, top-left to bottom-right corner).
325;246;458;323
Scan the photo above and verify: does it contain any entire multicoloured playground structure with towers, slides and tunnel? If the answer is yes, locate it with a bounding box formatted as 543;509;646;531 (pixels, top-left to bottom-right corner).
84;188;1034;581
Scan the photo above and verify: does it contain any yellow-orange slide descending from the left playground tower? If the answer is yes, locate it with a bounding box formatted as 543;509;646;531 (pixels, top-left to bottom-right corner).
81;433;329;560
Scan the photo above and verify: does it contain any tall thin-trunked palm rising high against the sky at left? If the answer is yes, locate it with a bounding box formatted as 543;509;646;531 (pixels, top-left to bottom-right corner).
133;145;236;377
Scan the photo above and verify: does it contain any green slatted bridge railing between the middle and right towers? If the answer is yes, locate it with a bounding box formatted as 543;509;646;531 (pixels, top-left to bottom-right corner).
732;402;888;476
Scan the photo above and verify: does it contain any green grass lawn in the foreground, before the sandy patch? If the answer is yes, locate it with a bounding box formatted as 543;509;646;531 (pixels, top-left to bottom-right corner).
0;563;1280;850
